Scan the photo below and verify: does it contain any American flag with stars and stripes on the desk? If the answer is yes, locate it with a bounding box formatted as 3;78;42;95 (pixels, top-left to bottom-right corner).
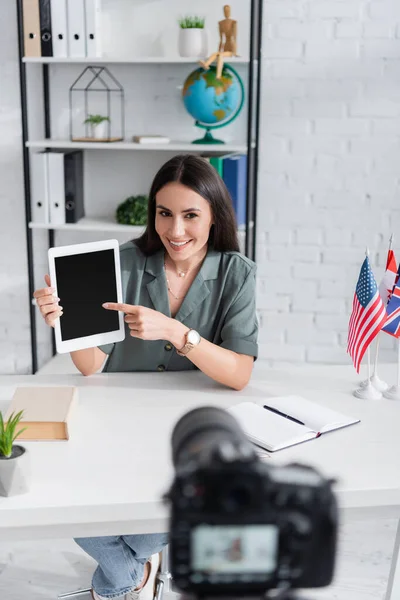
347;256;386;373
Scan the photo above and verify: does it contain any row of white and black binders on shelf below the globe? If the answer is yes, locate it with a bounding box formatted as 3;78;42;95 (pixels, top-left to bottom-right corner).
30;150;84;225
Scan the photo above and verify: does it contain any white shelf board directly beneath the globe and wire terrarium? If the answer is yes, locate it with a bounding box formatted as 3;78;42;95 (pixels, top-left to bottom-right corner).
26;139;247;153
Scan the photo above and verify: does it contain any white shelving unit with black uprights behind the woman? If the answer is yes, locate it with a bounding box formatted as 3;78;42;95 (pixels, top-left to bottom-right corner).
17;0;262;372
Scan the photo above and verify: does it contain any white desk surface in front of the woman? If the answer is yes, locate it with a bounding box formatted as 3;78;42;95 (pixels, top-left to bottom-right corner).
0;361;400;539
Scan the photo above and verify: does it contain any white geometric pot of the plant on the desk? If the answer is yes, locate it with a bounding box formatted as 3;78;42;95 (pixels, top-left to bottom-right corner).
0;445;31;496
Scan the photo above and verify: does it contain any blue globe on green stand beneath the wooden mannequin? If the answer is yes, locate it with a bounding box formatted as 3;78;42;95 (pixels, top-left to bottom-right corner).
182;65;244;144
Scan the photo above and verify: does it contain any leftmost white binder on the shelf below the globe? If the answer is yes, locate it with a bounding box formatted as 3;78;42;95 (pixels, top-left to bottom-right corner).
30;152;49;224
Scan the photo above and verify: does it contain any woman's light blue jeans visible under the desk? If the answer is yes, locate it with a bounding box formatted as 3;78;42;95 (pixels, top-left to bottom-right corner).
75;533;168;598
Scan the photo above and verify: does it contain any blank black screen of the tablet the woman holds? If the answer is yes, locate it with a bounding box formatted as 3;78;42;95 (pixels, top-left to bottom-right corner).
54;250;119;341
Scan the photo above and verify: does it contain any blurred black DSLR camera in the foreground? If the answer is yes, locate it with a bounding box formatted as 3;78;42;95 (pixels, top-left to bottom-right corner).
165;407;338;598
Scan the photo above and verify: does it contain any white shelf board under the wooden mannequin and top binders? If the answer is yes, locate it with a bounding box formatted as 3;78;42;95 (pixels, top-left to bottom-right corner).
22;56;249;65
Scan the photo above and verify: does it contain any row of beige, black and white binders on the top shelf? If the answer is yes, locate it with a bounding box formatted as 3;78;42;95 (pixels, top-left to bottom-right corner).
22;0;101;58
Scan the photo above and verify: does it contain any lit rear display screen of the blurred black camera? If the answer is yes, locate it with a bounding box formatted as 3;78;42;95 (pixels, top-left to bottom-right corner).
191;525;279;574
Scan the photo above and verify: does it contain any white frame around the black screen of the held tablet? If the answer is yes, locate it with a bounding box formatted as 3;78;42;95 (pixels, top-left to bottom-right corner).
48;240;125;354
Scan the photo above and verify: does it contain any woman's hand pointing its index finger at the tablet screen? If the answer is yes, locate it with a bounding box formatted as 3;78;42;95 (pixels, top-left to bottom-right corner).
103;302;178;340
